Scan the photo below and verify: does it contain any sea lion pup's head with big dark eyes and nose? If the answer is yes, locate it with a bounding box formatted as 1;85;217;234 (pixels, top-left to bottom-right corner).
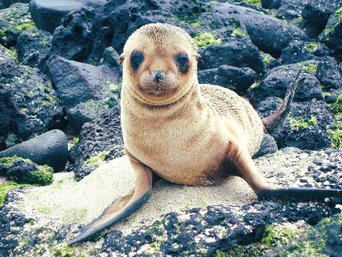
121;23;198;105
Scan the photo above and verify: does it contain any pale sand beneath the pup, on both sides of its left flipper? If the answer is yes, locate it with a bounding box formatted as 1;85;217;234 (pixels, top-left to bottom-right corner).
17;156;255;233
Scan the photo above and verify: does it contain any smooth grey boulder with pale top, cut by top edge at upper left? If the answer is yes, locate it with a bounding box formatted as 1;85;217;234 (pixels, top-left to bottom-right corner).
30;0;107;33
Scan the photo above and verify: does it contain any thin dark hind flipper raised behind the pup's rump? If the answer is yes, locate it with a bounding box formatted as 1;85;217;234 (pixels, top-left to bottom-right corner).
262;67;305;134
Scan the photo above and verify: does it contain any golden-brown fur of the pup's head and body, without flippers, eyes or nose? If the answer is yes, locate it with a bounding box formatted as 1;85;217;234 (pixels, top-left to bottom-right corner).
121;24;264;188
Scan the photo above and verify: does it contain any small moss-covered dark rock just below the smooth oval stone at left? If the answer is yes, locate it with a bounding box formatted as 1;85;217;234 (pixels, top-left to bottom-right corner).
22;165;53;186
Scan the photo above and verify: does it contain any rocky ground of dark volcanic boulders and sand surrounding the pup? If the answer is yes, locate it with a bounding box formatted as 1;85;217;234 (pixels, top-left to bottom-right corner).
0;0;342;256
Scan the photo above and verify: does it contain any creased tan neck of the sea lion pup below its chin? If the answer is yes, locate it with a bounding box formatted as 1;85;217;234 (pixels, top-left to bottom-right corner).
121;78;200;118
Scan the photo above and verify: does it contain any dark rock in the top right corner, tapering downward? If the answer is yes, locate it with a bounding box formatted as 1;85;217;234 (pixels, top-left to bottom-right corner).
302;0;342;36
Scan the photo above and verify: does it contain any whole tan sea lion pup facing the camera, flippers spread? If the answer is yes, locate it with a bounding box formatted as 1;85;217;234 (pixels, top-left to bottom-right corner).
70;23;341;244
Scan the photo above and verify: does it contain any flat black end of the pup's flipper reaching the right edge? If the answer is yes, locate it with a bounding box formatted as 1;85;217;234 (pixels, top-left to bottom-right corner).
256;187;342;203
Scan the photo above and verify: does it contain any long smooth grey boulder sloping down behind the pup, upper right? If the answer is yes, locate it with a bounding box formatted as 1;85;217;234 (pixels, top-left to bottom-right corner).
213;3;306;56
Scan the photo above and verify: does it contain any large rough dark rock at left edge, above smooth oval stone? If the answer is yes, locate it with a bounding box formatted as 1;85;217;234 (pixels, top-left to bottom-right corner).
0;46;63;149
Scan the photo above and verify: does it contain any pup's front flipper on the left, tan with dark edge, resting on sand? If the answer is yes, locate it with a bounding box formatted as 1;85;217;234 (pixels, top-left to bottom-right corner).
69;157;153;244
